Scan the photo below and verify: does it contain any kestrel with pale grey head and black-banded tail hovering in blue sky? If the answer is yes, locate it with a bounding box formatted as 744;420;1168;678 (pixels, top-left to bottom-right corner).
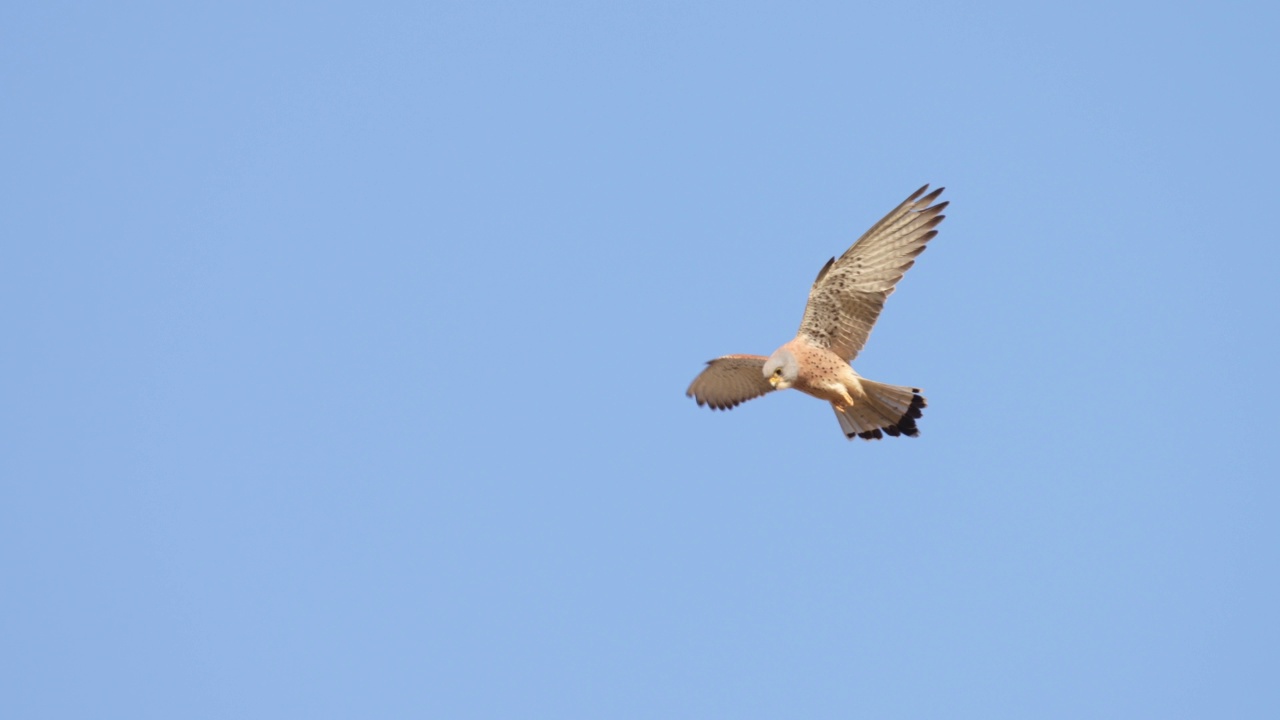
685;186;947;439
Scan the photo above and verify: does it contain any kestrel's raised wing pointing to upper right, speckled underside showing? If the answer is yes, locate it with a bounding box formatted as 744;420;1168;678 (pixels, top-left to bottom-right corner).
799;186;947;360
